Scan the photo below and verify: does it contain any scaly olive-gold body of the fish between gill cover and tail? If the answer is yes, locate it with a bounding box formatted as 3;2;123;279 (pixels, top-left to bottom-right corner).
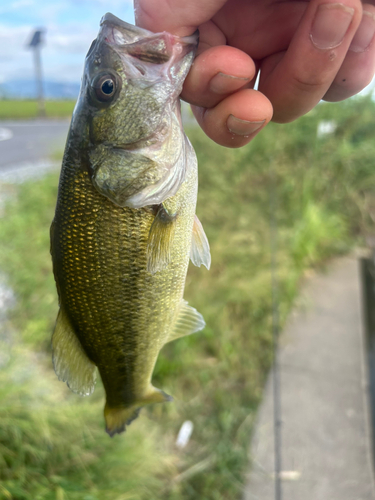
54;149;196;405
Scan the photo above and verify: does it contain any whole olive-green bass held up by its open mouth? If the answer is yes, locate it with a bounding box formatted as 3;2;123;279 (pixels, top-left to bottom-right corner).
51;9;211;436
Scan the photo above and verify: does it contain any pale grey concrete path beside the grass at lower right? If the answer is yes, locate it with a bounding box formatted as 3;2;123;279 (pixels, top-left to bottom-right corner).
244;257;375;500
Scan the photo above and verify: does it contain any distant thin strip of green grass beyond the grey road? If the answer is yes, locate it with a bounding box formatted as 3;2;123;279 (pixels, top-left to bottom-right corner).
0;99;75;120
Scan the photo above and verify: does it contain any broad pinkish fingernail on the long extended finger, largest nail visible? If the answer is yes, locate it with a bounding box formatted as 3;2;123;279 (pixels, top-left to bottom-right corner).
310;3;354;49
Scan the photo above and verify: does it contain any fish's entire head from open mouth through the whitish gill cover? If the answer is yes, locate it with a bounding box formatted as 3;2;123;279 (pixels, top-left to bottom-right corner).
71;14;198;208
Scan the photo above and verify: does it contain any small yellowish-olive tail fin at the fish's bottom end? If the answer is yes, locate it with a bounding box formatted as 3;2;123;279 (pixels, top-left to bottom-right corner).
104;386;173;437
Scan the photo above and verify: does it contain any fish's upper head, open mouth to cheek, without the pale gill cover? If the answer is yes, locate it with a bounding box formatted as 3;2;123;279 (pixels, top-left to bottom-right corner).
75;14;198;147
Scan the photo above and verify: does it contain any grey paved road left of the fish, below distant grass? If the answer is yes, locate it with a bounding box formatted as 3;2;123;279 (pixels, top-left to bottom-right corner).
0;120;69;172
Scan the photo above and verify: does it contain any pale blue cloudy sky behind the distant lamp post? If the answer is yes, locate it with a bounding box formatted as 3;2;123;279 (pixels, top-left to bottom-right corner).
0;0;134;84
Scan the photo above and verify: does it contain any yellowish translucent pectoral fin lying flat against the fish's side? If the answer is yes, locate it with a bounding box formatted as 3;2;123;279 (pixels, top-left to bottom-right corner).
147;205;176;274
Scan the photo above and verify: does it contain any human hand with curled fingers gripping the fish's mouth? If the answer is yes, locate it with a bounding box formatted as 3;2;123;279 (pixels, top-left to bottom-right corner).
135;0;375;147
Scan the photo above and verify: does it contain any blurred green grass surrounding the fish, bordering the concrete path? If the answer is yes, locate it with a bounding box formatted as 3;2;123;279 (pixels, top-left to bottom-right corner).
0;98;375;500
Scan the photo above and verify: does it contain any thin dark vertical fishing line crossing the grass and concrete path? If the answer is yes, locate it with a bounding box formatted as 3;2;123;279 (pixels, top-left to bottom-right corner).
270;161;282;500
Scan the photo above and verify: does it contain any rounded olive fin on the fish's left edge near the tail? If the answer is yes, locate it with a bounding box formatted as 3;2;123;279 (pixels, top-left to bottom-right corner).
52;308;96;396
